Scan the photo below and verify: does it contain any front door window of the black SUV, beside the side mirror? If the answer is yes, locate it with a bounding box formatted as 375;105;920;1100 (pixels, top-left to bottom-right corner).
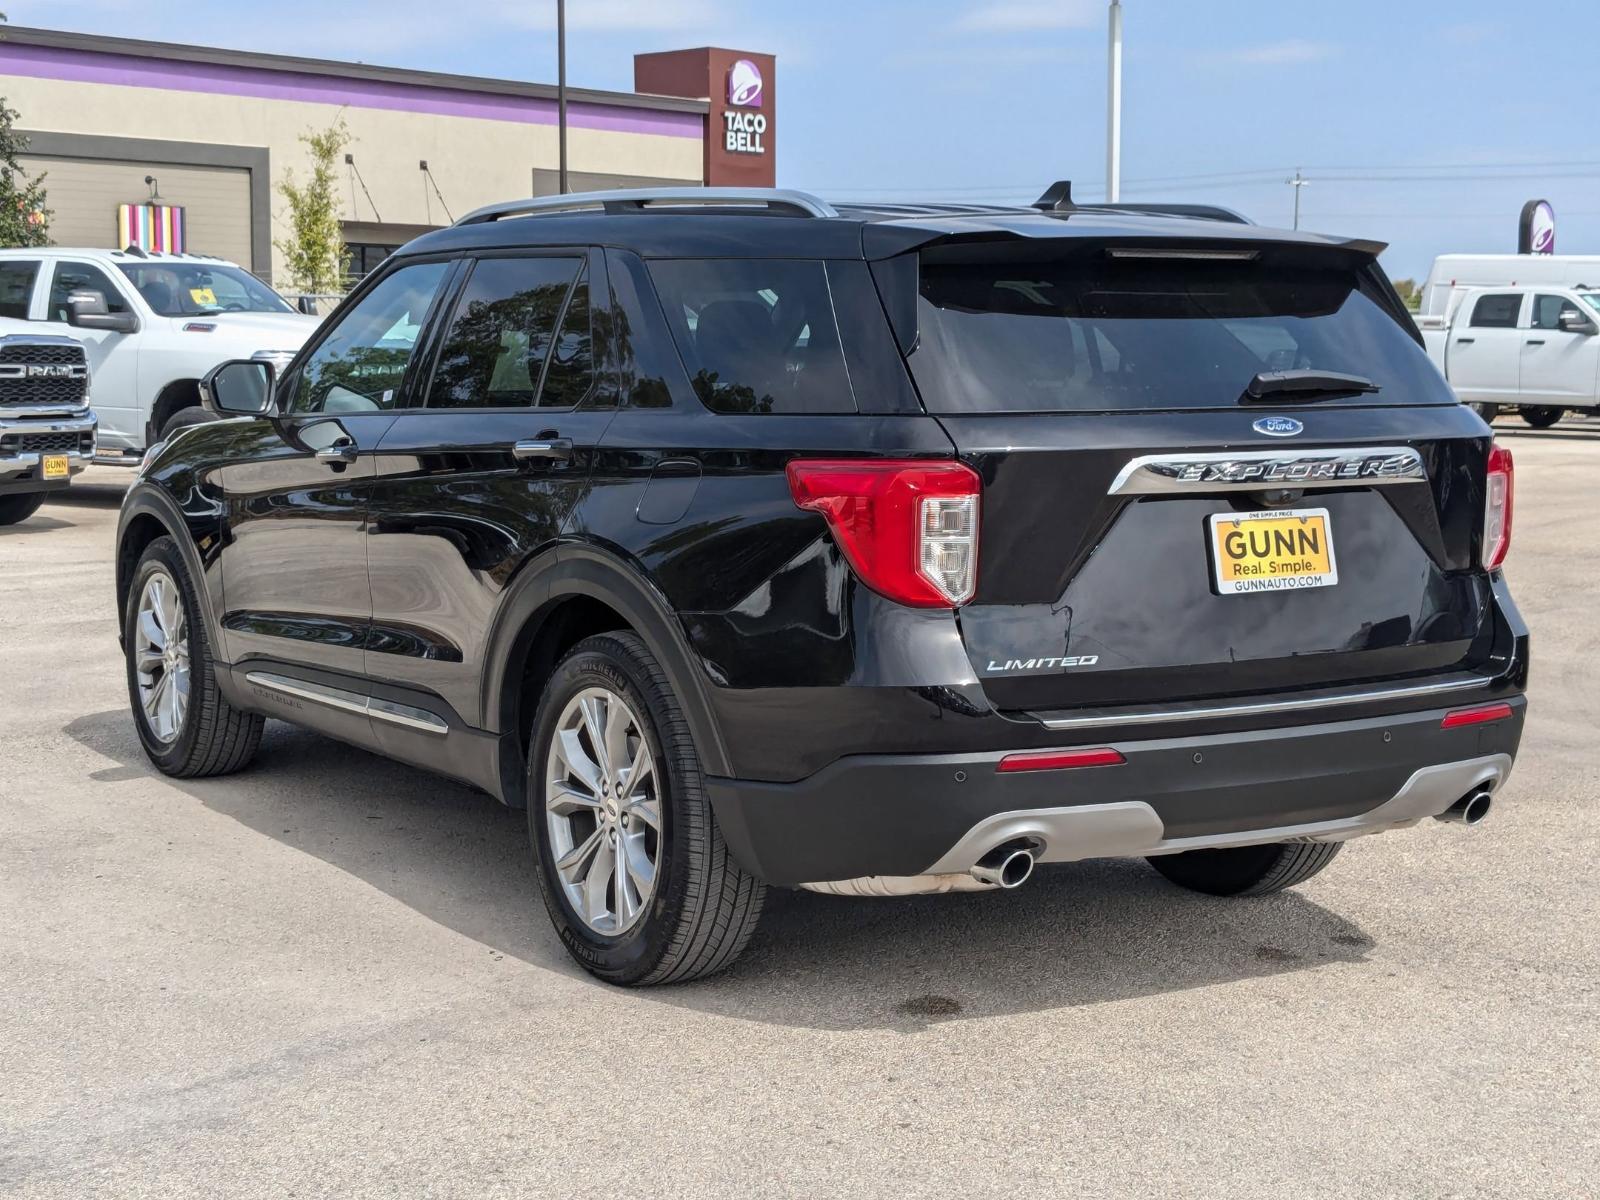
290;262;450;413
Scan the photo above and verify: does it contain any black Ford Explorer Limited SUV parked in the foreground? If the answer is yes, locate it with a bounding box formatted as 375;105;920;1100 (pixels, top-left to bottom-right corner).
117;187;1528;984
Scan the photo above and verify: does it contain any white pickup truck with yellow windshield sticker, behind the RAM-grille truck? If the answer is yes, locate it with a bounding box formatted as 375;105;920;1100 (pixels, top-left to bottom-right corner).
0;246;318;466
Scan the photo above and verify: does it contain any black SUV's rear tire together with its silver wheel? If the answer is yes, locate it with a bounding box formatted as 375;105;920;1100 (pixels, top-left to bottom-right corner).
528;632;766;987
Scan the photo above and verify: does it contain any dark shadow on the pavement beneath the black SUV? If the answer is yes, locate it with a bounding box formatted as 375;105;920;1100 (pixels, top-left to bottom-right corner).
66;710;1373;1032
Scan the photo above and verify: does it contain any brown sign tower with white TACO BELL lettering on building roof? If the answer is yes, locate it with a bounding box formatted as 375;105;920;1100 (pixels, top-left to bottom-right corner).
634;46;778;187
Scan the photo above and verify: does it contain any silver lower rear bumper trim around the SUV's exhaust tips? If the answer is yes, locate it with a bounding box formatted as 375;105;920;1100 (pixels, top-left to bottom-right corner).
915;754;1512;876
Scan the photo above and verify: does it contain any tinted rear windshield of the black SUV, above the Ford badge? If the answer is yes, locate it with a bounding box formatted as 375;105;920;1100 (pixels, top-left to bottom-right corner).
909;253;1454;413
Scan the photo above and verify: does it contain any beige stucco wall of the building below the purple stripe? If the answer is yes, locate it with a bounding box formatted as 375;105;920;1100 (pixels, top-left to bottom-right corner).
0;75;701;278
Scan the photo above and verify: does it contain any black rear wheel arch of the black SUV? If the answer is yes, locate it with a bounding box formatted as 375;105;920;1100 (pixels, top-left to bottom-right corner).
482;544;728;803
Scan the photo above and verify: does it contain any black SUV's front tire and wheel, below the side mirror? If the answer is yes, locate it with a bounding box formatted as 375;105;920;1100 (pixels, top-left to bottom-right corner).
123;538;266;779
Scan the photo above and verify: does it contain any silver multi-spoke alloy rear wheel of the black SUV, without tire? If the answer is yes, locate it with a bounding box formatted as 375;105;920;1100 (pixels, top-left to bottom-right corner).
544;688;666;936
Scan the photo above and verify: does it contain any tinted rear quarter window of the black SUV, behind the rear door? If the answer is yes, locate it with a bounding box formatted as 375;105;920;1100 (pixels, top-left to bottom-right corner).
650;259;856;413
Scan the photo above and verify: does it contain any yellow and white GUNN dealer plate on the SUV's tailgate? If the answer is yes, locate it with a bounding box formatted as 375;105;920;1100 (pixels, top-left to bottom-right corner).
1210;509;1339;595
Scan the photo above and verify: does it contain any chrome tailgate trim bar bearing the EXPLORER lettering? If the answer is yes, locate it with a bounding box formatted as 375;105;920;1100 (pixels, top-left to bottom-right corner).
1106;446;1427;496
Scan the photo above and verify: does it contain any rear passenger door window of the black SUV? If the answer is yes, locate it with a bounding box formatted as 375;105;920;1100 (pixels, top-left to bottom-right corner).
427;258;594;408
